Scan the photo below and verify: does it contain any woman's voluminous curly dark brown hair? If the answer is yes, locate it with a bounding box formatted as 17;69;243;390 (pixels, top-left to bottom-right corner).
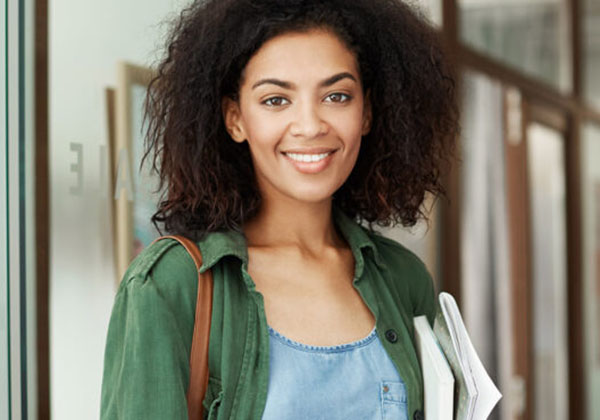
142;0;460;239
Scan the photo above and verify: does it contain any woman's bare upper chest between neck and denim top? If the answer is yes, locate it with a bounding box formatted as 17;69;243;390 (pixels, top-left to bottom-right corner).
244;248;375;346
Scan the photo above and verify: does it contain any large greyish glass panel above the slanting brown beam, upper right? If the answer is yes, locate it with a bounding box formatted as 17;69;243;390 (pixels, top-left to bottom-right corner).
458;0;571;91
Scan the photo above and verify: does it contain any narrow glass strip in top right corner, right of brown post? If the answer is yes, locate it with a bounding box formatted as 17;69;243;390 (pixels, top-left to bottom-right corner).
581;0;600;108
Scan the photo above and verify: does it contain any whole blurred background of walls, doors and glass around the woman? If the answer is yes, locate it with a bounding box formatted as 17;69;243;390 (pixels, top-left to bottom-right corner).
0;0;600;420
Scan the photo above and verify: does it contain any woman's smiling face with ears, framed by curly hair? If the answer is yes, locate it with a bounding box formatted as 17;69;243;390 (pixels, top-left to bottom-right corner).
223;30;371;207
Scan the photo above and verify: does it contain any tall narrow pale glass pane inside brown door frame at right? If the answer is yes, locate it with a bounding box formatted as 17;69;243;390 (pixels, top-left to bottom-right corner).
527;123;569;420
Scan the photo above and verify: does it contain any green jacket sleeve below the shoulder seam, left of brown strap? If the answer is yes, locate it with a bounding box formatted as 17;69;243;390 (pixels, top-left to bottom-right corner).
100;274;189;420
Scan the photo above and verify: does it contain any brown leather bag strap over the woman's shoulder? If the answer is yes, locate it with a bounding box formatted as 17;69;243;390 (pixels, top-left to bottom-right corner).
154;235;213;420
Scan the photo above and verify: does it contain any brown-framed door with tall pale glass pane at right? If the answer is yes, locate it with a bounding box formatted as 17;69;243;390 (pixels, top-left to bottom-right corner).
505;95;576;420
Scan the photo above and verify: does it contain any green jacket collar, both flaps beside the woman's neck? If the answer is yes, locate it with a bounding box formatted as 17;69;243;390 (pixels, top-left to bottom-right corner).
198;205;382;279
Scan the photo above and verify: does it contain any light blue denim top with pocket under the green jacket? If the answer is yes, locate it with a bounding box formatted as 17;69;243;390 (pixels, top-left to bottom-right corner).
262;327;408;420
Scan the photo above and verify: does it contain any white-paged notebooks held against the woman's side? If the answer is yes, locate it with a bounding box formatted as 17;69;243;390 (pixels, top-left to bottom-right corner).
414;292;502;420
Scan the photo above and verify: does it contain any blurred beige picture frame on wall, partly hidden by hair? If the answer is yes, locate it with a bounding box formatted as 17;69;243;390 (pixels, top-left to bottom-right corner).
109;62;161;284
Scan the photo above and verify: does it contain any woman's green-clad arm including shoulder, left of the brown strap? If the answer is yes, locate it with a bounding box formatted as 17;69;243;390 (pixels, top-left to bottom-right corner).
100;241;197;420
